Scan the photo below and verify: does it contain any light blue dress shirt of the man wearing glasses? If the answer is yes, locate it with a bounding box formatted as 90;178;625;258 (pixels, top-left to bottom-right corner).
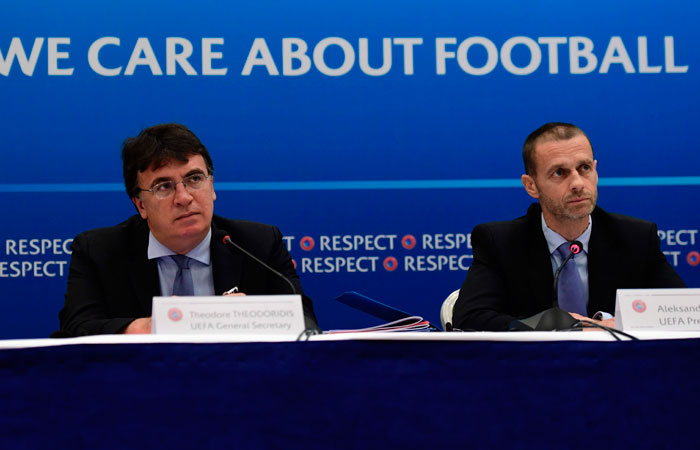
148;228;215;297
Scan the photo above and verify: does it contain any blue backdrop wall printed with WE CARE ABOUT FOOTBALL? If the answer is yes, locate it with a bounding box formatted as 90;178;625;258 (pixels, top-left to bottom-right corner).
0;0;700;338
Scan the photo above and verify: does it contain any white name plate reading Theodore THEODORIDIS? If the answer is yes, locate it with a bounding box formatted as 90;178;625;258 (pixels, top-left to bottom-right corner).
151;295;305;336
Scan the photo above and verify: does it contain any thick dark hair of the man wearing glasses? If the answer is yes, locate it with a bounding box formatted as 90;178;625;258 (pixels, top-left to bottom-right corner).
122;123;214;198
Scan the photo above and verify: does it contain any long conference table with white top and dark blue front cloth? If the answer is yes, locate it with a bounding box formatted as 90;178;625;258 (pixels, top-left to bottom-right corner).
0;332;700;449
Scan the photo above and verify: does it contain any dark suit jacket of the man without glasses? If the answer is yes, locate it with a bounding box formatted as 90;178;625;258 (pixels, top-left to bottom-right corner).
453;203;685;331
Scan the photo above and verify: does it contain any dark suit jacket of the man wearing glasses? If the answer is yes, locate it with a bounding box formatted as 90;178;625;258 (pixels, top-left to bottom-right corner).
58;215;316;335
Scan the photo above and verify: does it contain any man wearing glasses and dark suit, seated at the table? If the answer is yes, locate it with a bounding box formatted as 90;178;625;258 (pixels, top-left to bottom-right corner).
59;124;317;335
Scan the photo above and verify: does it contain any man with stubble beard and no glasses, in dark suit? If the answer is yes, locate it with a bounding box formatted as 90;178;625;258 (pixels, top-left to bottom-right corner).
453;123;685;331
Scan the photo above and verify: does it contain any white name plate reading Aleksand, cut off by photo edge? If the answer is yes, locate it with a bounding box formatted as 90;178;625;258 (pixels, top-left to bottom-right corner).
615;289;700;331
